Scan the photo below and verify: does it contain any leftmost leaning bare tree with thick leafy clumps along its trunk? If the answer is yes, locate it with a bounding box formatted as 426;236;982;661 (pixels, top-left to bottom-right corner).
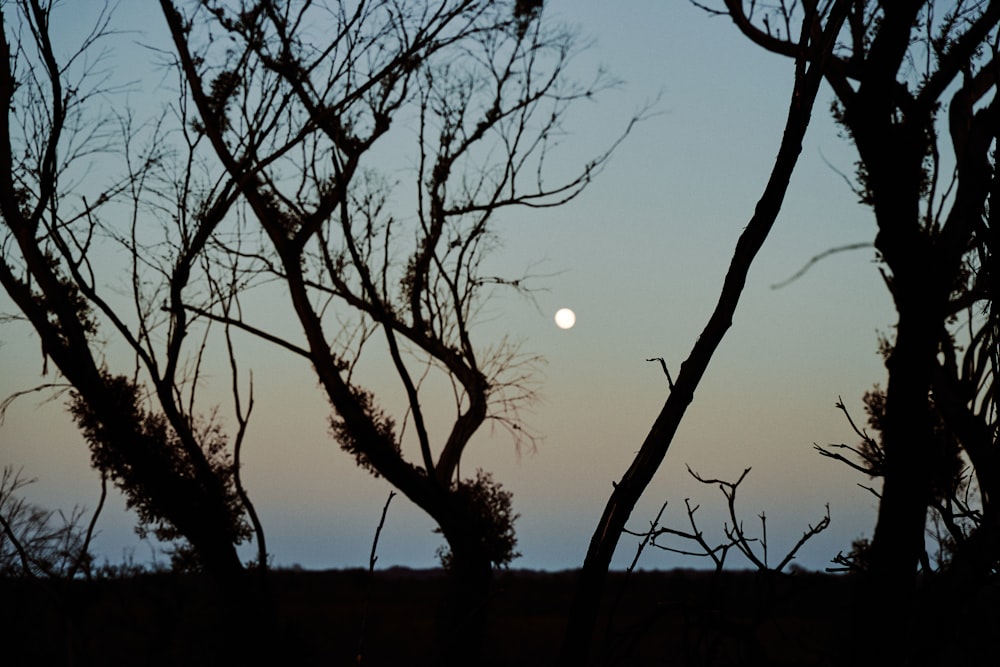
0;0;264;586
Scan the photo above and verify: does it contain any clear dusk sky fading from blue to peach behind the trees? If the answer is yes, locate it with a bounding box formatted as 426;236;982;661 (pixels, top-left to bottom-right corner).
0;0;894;570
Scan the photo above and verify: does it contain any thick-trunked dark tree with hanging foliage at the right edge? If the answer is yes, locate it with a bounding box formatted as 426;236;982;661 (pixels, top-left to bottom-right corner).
704;1;1000;587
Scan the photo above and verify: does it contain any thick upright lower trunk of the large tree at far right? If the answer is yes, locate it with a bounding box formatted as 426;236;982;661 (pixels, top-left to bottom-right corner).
855;264;947;665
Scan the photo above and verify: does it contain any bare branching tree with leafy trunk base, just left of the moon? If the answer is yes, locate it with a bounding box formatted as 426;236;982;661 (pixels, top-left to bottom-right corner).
154;0;627;660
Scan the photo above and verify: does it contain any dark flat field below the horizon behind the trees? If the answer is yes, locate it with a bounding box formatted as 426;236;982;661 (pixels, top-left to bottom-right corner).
0;569;1000;667
